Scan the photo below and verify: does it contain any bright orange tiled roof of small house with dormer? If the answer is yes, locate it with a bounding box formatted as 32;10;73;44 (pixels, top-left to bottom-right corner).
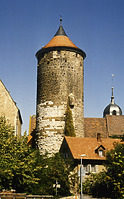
65;137;121;160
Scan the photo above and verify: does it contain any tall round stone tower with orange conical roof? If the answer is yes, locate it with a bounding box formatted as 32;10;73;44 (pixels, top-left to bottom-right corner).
36;19;86;154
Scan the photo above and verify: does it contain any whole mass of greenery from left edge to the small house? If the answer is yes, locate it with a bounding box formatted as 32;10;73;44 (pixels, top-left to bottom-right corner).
0;118;70;195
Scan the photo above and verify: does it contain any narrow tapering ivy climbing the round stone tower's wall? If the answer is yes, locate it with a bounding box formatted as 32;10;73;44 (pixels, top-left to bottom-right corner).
64;103;76;137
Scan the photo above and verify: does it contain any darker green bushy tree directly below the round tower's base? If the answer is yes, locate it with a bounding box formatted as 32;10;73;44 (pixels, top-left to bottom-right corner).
39;153;70;196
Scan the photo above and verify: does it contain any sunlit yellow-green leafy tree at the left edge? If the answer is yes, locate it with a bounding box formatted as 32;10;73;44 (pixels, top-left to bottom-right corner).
0;117;41;193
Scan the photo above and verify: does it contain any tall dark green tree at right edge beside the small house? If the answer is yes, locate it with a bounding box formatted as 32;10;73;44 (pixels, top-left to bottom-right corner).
106;143;124;198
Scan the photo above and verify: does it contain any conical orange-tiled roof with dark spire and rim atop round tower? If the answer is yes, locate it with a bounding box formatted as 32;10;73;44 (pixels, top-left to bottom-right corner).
36;19;86;59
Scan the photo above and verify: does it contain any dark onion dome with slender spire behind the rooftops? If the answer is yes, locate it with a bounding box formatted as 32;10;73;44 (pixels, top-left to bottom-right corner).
103;87;122;117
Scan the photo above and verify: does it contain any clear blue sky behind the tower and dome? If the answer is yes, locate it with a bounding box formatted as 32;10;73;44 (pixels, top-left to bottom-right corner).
0;0;124;133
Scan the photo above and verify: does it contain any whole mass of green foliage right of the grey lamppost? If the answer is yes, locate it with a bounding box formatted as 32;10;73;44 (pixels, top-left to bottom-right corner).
83;144;124;199
